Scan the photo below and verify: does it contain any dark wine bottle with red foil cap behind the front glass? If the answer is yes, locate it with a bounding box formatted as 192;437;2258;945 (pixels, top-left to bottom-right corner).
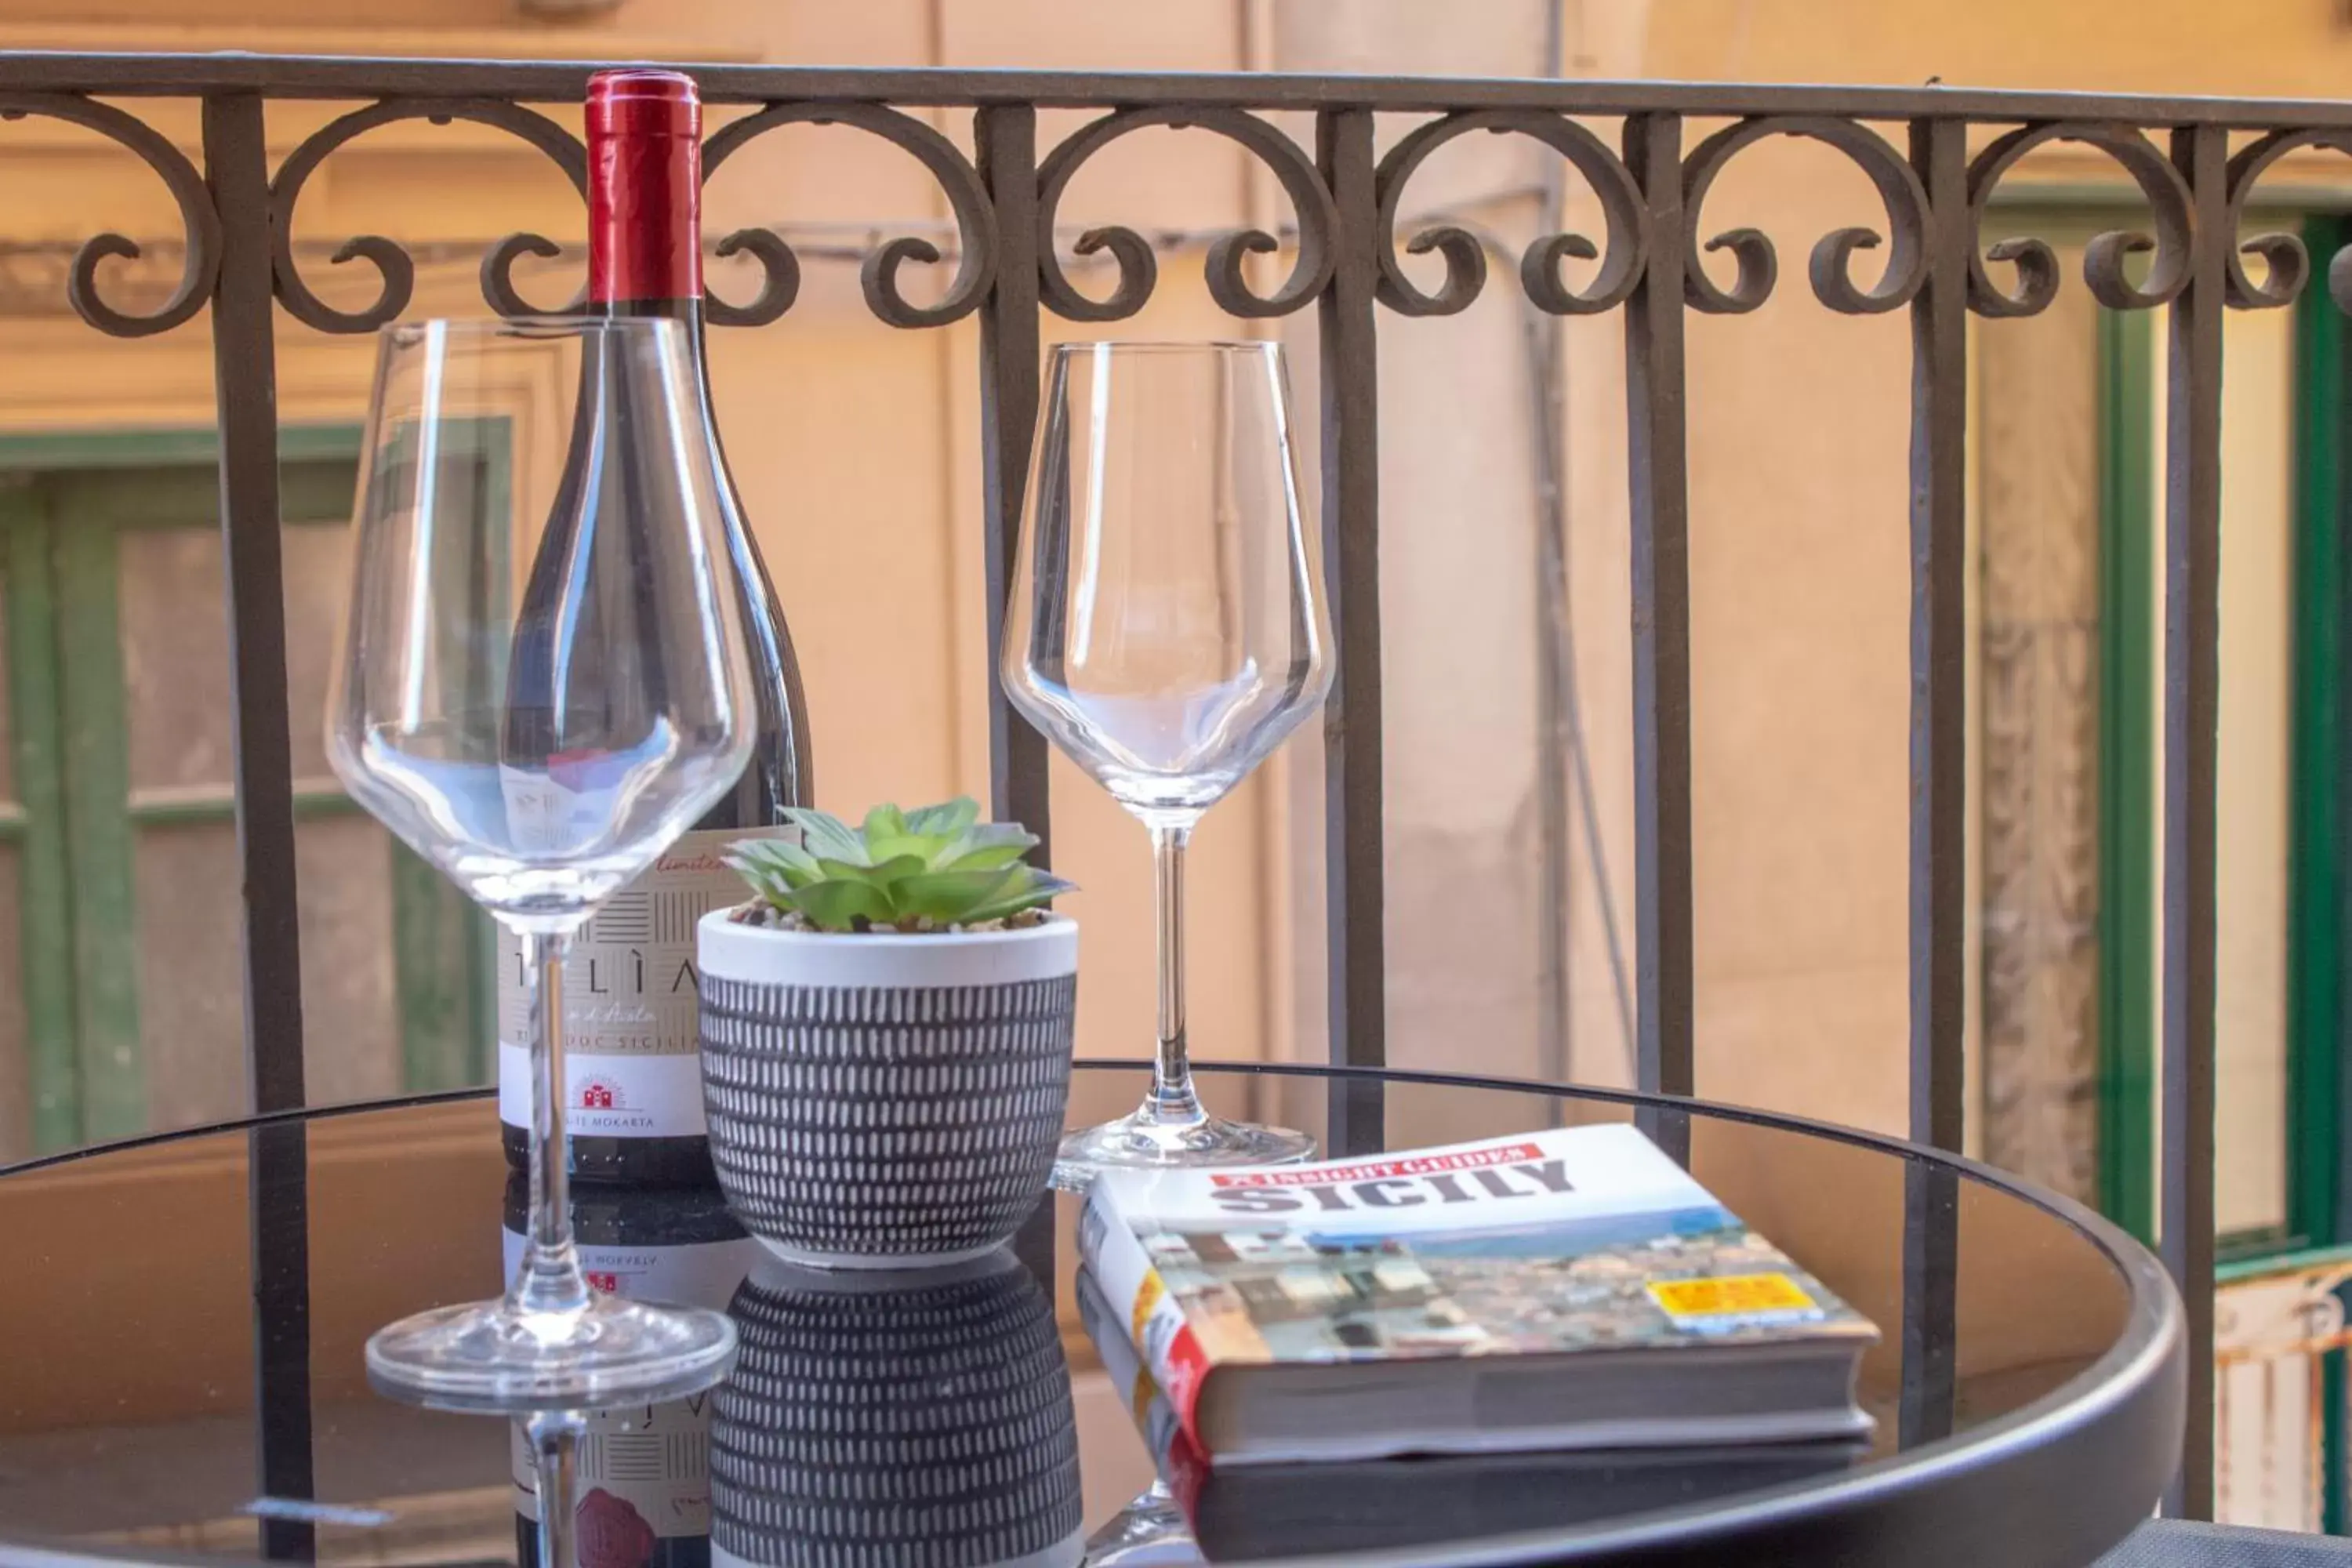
499;71;809;1185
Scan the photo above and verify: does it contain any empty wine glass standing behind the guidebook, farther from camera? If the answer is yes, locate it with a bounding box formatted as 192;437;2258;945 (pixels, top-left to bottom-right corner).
1004;343;1331;1185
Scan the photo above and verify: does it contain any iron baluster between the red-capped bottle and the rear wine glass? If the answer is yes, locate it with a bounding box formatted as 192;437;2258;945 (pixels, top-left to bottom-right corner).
971;103;1054;865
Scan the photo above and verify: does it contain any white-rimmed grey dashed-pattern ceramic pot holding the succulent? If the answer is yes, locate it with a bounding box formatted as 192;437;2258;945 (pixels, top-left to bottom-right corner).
699;912;1077;1269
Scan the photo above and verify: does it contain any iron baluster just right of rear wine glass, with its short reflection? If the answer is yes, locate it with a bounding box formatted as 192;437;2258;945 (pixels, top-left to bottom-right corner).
1315;108;1388;1154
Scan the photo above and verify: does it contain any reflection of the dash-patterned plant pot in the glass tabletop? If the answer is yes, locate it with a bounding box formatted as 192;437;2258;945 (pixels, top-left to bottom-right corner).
710;1258;1080;1568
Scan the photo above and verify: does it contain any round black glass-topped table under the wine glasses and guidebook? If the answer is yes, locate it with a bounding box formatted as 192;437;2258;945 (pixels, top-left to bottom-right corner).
0;1062;2183;1568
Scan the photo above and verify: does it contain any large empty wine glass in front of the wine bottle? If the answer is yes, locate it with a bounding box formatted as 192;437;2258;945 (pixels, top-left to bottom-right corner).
327;318;753;1410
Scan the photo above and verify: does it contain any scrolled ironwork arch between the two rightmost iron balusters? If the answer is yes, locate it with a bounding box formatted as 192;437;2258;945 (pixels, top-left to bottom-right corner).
1969;120;2194;318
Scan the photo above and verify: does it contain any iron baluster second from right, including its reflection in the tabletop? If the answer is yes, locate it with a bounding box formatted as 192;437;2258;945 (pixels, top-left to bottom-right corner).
1900;120;1971;1448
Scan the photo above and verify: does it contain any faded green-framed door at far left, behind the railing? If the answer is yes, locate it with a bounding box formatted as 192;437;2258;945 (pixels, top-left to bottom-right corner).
0;435;489;1159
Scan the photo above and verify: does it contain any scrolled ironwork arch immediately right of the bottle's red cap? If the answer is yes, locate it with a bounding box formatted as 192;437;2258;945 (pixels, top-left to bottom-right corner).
703;101;997;327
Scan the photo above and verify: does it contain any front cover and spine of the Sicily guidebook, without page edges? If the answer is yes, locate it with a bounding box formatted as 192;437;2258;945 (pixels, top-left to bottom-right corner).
1080;1126;1877;1441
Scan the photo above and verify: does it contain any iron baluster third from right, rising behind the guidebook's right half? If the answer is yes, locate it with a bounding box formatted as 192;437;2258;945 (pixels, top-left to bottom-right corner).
1625;113;1693;1095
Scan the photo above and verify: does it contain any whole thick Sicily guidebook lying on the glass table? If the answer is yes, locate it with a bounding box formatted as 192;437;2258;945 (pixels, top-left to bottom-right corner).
1080;1126;1877;1465
